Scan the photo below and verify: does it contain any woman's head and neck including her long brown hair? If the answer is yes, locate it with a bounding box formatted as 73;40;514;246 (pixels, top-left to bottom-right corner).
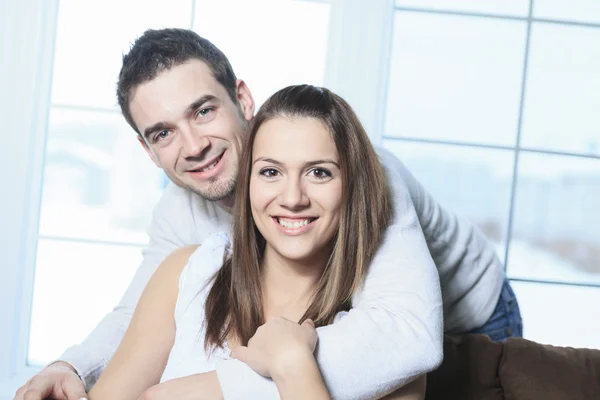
205;85;392;348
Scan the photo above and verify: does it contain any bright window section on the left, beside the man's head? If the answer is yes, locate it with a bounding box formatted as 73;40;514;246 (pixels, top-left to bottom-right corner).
27;0;192;365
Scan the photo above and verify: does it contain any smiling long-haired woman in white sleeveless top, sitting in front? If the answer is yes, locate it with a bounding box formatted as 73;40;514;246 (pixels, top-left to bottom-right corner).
90;85;424;400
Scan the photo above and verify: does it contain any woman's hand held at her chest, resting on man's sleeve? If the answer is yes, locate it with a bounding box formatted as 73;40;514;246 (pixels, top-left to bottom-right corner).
232;317;318;378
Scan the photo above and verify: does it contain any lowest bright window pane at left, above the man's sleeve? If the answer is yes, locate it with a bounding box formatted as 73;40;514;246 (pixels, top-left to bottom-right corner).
28;239;142;365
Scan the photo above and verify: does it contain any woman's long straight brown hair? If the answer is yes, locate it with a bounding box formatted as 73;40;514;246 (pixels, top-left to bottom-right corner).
204;85;393;350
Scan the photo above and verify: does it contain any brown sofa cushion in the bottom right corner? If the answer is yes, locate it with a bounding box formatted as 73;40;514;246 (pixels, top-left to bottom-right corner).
499;339;600;400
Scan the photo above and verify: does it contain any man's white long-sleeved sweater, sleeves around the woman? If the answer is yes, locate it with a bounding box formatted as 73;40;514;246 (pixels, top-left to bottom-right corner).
60;149;504;400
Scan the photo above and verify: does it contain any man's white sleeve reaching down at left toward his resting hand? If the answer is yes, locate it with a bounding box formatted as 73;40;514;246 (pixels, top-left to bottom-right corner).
54;184;200;390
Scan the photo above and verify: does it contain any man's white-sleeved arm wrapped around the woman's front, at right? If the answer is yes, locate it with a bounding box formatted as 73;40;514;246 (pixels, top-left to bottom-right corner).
217;154;443;400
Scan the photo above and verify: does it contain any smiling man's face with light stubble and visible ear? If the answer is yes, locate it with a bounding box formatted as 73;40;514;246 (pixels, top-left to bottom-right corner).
129;60;254;201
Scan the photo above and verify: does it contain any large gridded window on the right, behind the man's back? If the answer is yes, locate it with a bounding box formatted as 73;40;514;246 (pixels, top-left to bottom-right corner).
383;0;600;348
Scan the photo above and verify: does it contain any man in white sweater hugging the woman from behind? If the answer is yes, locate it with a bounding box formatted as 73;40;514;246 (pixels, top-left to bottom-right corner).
16;29;520;400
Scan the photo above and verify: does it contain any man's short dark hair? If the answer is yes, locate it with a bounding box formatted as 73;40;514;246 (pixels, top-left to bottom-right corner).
117;28;237;134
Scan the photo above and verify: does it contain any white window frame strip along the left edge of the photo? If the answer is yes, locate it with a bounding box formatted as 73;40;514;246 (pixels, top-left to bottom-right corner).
0;0;58;398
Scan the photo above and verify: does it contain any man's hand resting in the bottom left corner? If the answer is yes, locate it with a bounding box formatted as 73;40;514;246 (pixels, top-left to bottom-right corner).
15;361;87;400
